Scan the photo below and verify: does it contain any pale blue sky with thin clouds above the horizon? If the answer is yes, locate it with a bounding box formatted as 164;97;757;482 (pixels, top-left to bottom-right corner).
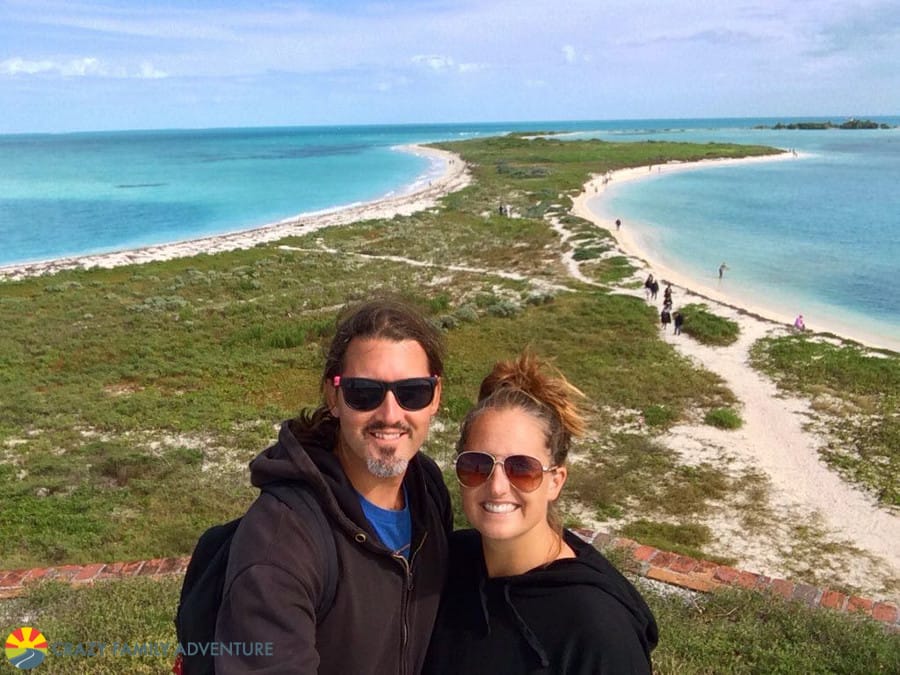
0;0;900;133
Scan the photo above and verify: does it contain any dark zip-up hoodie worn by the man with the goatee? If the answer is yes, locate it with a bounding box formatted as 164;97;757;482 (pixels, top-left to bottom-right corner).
215;422;452;675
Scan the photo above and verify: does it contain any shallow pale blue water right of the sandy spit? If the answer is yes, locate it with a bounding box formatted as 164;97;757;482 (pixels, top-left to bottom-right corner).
584;120;900;339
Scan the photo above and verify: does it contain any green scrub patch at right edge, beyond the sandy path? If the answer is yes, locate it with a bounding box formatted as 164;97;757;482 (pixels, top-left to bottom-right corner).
751;335;900;506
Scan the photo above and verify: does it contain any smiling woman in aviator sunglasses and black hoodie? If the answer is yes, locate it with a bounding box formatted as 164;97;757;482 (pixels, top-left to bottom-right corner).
424;354;657;675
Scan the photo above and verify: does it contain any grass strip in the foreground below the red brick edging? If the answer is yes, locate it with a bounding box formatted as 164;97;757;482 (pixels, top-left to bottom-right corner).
0;572;900;675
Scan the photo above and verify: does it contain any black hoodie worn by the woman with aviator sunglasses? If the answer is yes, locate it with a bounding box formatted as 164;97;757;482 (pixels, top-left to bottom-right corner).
424;530;658;675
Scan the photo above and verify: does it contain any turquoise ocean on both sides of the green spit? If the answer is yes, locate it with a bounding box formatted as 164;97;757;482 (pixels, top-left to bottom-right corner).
0;117;900;348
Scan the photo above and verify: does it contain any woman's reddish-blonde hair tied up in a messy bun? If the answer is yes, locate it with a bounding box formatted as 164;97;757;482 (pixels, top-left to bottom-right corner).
456;351;585;530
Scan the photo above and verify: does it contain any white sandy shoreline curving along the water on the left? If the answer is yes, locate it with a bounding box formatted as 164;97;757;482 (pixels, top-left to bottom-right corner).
0;145;471;282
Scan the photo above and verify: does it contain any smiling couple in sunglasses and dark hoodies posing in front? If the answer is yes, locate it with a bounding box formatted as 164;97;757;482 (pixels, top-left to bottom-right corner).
184;299;658;675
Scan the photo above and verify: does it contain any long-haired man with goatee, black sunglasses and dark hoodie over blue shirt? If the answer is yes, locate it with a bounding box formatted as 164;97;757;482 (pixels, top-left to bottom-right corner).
215;300;452;675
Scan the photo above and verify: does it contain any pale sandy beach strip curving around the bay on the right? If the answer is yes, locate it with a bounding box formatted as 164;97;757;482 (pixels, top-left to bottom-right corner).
572;151;900;352
